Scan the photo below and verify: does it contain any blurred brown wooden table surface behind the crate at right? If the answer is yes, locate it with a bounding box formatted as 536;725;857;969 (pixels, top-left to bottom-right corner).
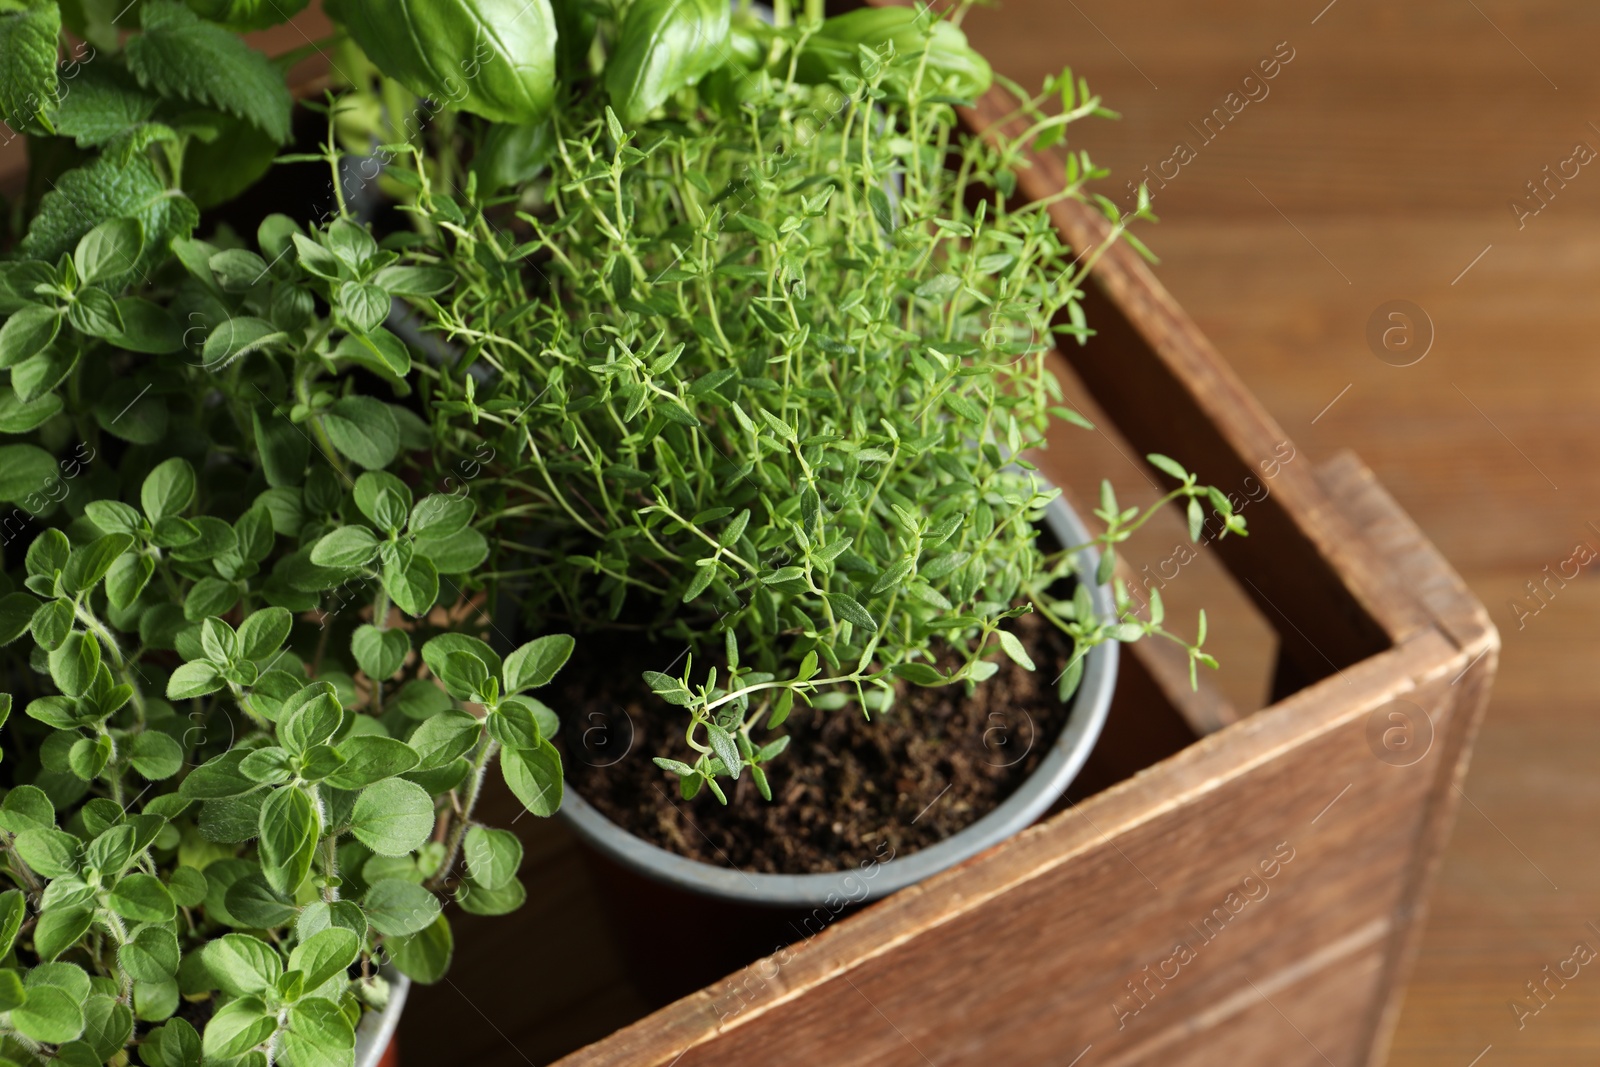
968;0;1600;1067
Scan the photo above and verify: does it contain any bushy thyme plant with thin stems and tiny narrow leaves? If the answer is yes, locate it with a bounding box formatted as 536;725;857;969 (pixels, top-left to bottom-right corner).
393;4;1243;800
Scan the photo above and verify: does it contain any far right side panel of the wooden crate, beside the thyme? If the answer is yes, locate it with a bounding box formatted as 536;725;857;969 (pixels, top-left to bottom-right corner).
940;90;1429;677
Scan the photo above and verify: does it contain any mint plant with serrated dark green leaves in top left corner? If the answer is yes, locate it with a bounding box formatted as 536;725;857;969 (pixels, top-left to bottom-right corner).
0;0;306;260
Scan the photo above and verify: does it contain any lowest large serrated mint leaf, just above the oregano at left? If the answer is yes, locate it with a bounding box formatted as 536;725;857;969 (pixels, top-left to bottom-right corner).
21;154;200;285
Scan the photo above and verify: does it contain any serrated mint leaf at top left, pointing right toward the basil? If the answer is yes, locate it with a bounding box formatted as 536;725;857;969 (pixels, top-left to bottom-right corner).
125;0;293;144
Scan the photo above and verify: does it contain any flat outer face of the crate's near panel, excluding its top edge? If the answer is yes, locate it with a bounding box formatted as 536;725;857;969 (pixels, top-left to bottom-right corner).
646;668;1450;1067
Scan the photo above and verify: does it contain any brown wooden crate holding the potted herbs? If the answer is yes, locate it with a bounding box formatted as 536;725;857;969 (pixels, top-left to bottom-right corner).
402;75;1499;1067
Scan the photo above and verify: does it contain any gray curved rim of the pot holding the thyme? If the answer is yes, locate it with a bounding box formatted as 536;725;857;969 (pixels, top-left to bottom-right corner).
560;498;1117;909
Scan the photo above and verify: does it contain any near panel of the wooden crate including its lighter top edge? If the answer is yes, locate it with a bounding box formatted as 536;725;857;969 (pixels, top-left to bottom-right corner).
562;633;1459;1067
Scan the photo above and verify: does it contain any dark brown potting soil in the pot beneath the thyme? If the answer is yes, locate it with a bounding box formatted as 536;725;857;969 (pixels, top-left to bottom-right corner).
546;614;1072;873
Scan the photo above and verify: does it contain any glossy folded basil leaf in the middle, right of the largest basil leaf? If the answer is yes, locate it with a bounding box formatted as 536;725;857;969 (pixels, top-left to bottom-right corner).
605;0;730;126
